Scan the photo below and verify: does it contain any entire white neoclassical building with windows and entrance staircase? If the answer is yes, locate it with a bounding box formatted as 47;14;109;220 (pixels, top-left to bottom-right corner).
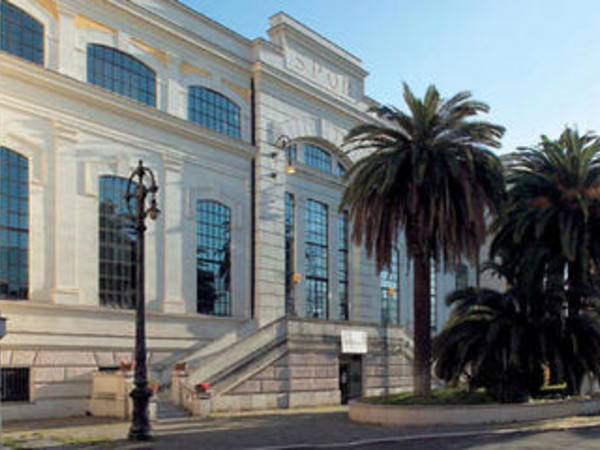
0;0;472;420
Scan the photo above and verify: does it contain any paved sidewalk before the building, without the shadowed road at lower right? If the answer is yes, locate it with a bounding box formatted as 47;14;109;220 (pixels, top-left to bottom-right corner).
2;408;600;450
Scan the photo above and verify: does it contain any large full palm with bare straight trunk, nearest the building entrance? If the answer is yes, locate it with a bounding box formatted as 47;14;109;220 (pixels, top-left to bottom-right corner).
341;84;504;395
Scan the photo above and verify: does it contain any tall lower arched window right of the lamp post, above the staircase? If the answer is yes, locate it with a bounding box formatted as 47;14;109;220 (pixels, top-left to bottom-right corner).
196;200;231;316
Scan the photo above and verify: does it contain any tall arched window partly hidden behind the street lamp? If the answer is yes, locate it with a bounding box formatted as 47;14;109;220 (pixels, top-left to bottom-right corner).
98;175;137;309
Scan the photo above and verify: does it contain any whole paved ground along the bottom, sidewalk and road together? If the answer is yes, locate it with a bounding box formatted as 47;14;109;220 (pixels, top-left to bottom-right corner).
3;408;600;450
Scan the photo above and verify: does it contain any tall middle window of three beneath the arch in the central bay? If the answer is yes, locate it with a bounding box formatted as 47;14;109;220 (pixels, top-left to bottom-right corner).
305;200;329;319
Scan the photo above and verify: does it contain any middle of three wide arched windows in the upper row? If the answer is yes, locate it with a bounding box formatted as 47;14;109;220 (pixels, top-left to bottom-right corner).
87;44;156;106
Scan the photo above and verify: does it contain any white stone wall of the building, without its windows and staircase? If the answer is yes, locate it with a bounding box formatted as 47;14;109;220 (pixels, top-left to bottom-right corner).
0;0;468;420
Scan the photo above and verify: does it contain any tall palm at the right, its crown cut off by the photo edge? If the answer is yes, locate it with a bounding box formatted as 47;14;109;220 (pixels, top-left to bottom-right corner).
491;127;600;393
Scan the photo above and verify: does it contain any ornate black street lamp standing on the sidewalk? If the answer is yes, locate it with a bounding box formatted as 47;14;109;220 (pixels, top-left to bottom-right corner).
125;160;160;441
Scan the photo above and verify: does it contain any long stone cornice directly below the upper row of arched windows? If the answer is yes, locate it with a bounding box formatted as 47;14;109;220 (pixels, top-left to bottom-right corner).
0;52;256;159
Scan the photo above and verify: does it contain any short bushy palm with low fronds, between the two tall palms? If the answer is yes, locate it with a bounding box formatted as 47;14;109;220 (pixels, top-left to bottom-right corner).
434;286;554;403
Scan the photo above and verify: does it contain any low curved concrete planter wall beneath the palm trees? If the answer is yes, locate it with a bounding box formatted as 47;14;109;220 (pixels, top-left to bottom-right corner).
348;397;600;426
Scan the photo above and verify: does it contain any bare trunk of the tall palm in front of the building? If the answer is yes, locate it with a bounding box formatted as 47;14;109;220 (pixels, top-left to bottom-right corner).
413;254;431;395
